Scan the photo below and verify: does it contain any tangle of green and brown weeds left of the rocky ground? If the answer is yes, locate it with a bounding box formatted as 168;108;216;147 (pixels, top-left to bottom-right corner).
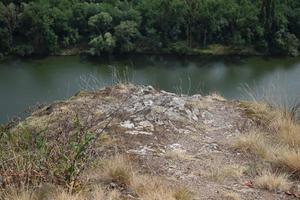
0;117;97;190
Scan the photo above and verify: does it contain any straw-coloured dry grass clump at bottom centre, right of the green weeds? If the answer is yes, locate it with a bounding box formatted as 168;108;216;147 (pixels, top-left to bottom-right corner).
88;156;192;200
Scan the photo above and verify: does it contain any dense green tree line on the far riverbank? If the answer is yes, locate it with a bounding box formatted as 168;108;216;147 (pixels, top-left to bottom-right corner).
0;0;300;56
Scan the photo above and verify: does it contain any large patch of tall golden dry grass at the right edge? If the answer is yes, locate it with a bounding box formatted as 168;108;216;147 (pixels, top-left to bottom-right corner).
234;103;300;159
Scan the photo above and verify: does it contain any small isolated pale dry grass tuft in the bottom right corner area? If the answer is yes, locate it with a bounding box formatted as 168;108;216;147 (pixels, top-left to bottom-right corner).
254;171;292;191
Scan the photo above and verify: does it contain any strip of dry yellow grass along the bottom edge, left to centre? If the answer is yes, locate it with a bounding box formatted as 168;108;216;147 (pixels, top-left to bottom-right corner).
4;156;193;200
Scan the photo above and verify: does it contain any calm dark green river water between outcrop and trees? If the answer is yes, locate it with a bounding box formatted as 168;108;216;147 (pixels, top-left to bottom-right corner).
0;55;300;123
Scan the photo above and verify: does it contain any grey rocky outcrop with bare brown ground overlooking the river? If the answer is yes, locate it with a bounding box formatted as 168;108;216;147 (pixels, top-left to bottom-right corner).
9;85;292;199
